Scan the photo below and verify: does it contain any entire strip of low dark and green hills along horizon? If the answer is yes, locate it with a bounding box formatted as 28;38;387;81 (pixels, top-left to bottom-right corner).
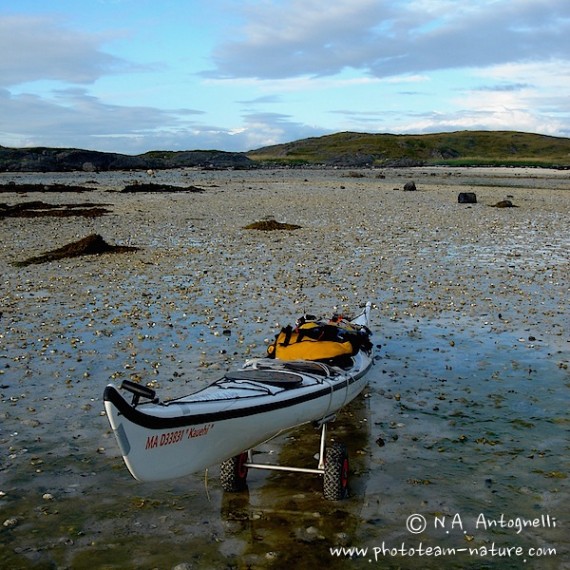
0;131;570;172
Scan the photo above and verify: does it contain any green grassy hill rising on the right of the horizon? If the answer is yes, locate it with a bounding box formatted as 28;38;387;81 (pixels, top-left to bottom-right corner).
247;131;570;167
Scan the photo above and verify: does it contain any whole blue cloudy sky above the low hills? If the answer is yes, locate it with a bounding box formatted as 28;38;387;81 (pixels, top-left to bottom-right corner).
0;0;570;154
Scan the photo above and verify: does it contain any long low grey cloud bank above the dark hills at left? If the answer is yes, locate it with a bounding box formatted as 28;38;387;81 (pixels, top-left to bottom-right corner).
0;82;328;154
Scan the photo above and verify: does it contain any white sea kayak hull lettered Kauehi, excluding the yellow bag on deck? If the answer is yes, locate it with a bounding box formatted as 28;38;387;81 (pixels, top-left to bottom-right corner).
104;303;372;481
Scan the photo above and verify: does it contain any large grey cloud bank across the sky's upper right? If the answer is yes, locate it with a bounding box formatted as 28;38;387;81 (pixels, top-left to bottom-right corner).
207;0;570;79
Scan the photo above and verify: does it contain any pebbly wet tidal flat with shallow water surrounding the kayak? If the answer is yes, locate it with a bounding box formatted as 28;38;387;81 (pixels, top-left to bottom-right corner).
0;168;570;570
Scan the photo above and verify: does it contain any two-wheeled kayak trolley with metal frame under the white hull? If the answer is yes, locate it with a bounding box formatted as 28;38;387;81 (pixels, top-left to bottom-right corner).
220;415;348;501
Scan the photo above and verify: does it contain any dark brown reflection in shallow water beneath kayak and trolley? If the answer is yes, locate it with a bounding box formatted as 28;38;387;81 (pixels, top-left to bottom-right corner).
221;394;370;568
